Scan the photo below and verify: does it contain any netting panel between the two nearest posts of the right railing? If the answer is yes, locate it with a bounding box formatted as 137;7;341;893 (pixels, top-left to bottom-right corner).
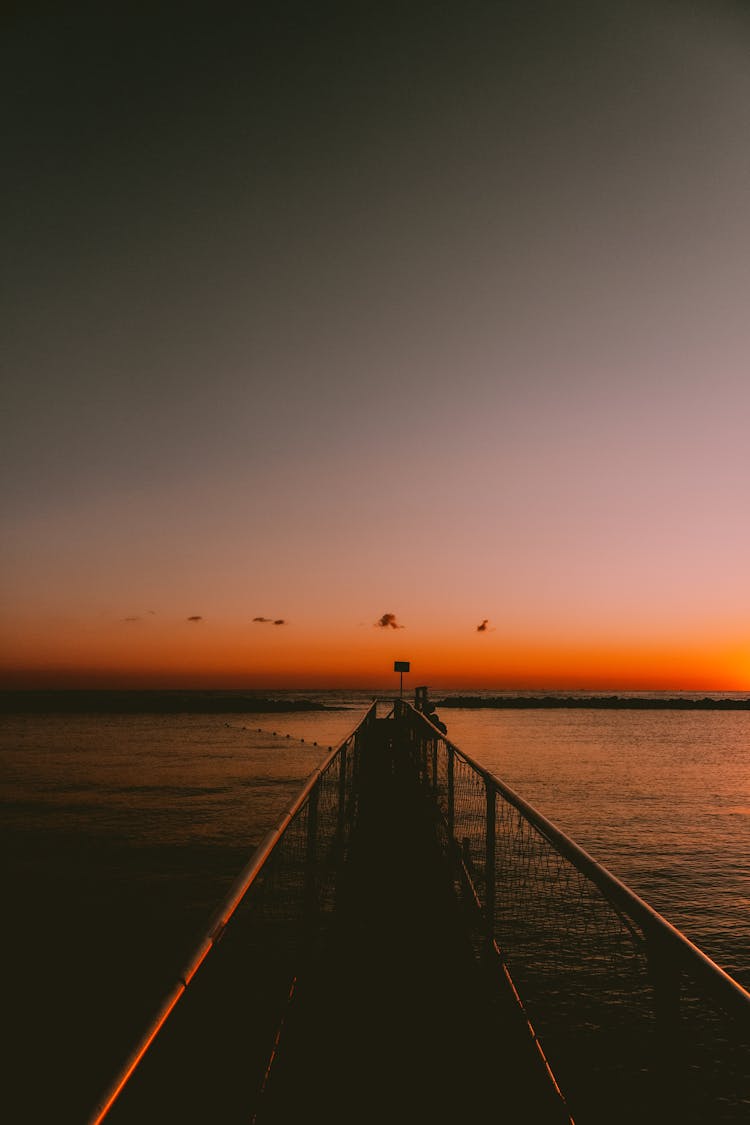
494;801;654;1118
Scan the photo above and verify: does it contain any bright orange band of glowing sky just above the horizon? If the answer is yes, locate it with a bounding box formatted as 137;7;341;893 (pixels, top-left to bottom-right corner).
0;623;750;692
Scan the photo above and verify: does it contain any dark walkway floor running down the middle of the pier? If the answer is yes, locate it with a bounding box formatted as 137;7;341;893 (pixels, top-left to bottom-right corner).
256;719;569;1125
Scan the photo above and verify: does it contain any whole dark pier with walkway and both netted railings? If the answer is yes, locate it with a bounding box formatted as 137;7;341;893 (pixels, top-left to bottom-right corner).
89;694;750;1125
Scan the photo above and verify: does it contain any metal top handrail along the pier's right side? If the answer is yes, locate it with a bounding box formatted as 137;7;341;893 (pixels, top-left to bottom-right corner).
400;700;750;1029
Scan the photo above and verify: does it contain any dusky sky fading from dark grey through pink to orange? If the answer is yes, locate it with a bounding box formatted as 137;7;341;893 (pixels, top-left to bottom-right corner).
0;0;750;691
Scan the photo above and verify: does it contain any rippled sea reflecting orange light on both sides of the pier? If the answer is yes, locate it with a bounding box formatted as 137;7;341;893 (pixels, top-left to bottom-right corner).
0;689;750;1125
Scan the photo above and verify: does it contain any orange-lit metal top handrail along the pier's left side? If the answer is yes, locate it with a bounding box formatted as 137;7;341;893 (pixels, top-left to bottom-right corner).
88;701;377;1125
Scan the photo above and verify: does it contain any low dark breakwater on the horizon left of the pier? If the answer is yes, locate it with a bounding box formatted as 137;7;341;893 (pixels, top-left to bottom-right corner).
0;689;338;714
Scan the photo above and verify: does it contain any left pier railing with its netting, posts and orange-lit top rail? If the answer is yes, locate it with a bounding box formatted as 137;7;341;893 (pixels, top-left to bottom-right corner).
89;703;377;1125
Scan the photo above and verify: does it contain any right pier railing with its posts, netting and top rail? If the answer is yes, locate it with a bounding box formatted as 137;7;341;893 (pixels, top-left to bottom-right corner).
396;701;750;1125
